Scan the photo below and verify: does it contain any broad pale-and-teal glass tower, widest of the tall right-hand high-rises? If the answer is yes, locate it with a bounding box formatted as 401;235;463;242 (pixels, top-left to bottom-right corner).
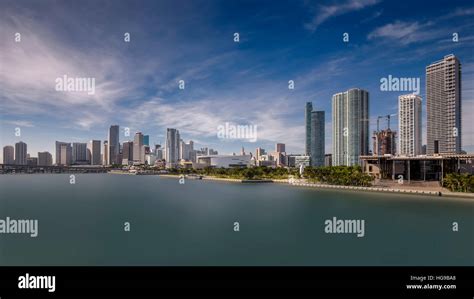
332;88;369;166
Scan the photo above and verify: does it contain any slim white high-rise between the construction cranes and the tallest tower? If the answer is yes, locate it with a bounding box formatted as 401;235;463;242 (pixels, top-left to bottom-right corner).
398;94;421;156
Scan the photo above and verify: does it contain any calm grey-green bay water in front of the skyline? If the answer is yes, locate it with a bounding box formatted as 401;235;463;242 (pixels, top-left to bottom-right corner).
0;174;474;266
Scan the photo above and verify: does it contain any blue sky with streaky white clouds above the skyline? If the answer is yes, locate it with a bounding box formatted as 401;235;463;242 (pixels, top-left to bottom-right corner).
0;0;474;162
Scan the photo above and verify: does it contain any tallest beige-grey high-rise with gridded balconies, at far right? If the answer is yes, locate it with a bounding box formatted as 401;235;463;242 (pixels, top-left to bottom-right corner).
426;54;462;155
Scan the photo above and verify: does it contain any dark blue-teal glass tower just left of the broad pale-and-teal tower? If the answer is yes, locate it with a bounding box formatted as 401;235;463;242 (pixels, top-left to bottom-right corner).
310;111;325;167
